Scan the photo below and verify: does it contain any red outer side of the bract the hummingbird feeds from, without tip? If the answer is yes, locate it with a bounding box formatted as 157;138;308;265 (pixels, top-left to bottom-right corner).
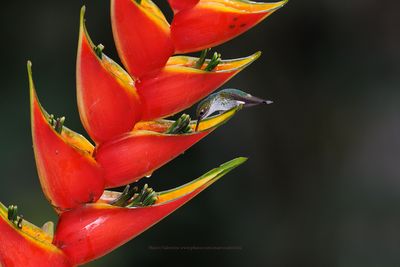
96;131;208;188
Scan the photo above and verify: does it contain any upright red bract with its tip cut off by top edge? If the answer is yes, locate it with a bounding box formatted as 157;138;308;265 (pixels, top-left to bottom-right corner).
111;0;174;77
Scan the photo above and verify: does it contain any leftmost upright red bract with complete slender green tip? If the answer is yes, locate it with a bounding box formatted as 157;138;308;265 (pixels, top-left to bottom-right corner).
28;62;104;211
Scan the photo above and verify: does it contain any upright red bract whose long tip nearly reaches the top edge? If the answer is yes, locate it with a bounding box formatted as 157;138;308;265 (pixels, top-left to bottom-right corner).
76;7;141;143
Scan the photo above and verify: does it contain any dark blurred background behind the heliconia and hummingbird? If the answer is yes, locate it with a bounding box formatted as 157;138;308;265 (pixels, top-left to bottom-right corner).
0;0;400;266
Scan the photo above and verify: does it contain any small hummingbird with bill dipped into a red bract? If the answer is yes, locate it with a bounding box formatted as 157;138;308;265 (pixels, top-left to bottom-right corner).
195;89;273;131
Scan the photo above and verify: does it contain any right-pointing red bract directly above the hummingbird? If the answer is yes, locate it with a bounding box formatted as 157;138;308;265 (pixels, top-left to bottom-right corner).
136;52;261;120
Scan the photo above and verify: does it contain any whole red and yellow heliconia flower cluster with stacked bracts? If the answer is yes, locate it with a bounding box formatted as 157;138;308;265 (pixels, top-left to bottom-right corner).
0;0;286;267
